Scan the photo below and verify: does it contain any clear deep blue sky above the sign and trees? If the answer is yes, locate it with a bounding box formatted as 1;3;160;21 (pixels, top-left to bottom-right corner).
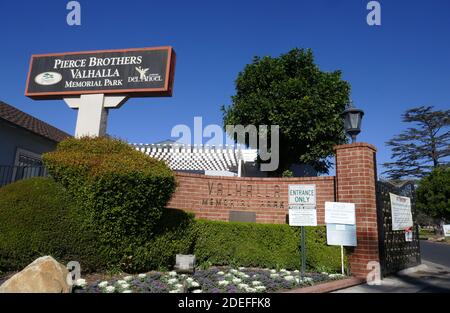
0;0;450;173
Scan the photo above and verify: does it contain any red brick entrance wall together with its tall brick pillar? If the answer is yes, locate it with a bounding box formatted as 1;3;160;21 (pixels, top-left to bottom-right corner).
168;143;379;278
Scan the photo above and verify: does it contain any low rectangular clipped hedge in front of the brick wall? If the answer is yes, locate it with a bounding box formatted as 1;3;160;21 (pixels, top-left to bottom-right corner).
194;220;340;272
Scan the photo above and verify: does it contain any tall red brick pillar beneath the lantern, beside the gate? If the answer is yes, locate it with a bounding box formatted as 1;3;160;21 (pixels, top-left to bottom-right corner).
334;143;379;279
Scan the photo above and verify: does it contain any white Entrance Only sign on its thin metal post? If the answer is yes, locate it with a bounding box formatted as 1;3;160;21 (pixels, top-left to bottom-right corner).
289;185;317;277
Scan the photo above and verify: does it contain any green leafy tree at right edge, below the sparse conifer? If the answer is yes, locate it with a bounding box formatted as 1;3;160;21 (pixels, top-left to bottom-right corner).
416;167;450;221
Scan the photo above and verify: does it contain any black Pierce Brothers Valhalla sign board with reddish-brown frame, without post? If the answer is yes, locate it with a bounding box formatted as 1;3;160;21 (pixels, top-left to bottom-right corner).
25;47;175;99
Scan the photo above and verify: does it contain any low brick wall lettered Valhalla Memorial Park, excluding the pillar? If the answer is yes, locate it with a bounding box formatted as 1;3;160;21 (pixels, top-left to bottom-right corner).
168;172;335;224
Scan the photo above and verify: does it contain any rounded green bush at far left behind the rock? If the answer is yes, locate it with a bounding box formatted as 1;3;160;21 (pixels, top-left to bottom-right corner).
0;178;105;272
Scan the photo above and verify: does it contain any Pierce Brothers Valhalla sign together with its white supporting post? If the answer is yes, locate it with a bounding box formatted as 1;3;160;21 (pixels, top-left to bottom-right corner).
25;47;175;137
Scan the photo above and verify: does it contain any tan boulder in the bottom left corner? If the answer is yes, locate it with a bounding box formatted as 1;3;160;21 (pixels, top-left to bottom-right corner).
0;256;71;293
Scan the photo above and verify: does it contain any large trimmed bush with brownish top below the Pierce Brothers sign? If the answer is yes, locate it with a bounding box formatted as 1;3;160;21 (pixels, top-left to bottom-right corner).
43;137;175;266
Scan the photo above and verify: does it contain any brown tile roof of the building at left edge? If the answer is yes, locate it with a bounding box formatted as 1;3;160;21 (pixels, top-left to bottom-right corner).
0;101;71;142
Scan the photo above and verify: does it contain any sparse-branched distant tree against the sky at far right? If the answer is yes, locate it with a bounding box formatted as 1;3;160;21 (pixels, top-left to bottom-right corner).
383;106;450;179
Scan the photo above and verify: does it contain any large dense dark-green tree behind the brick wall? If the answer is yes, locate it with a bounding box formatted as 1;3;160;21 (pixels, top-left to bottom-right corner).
222;49;350;176
